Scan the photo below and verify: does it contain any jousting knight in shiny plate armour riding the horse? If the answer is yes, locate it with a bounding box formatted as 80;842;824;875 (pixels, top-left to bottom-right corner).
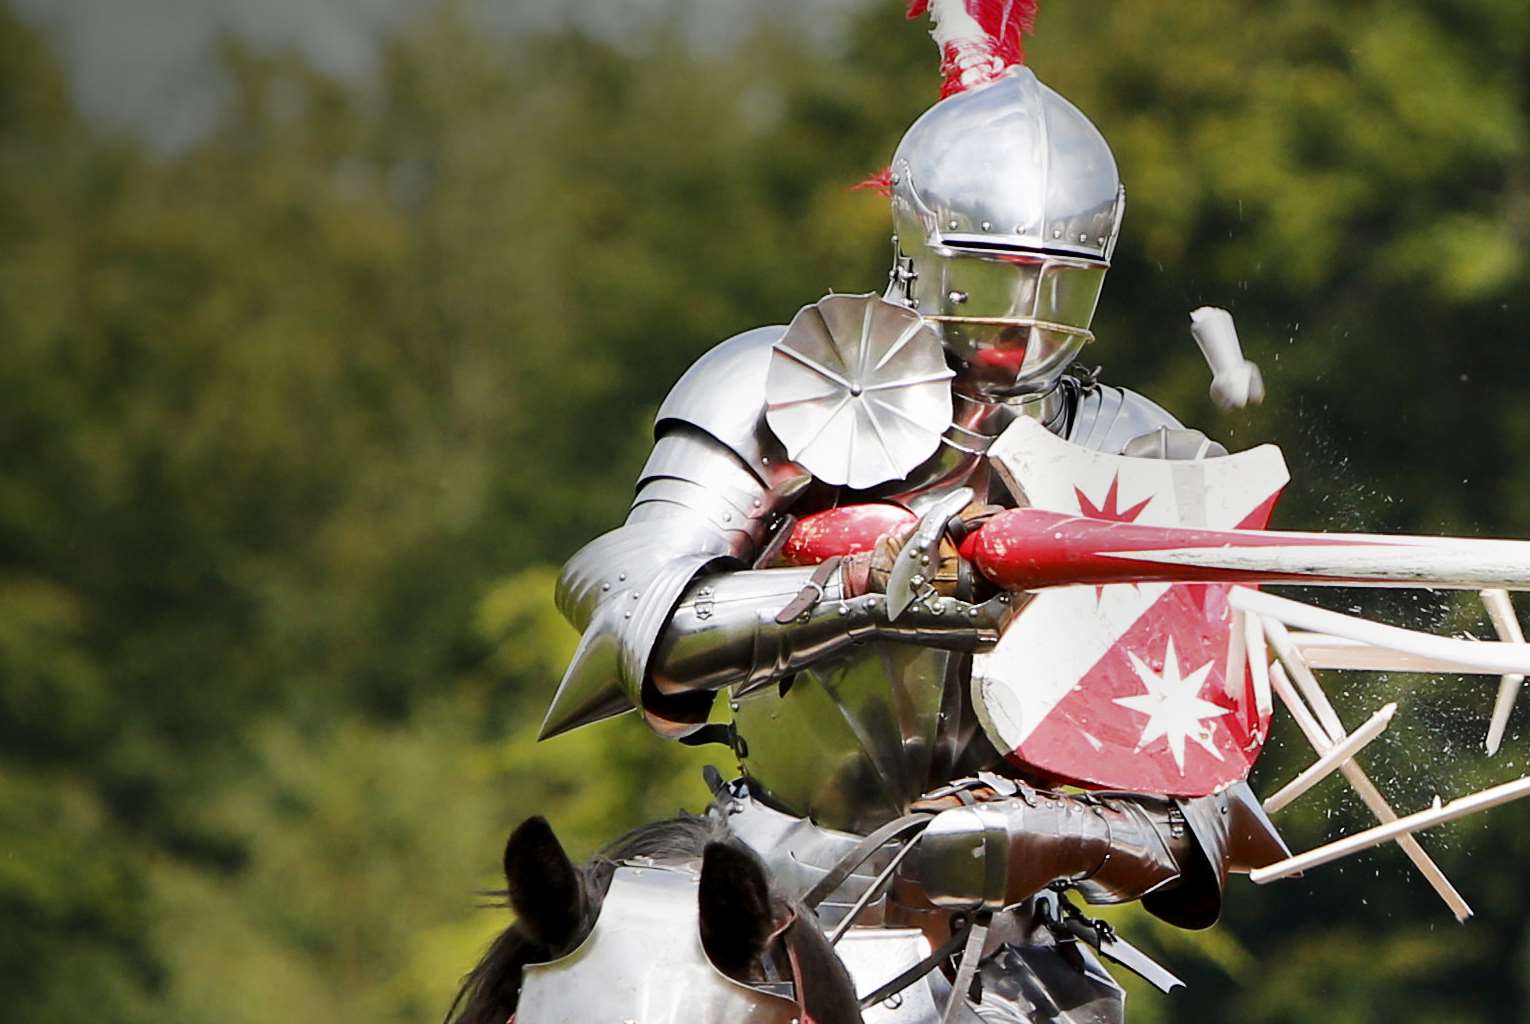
543;0;1285;1021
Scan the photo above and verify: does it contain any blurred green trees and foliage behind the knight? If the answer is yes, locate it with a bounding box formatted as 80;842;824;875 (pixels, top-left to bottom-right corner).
0;0;1530;1024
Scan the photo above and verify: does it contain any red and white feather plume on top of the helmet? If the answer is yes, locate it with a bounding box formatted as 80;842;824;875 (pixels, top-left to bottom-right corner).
909;0;1036;99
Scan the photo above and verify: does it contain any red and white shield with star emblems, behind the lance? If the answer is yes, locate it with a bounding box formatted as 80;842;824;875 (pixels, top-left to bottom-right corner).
973;419;1290;796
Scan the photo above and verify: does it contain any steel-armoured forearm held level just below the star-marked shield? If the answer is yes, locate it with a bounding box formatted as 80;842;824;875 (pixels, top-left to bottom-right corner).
907;784;1290;928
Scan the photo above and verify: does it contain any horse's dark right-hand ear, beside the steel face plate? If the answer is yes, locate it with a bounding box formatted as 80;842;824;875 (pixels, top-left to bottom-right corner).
696;842;776;975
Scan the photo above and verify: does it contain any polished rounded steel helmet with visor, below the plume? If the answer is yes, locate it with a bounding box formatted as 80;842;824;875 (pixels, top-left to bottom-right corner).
890;66;1126;398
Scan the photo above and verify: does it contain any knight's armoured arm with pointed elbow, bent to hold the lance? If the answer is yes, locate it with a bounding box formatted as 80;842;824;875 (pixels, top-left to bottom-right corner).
542;328;998;738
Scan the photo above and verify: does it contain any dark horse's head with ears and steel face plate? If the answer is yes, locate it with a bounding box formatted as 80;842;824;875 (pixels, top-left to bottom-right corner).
447;817;861;1024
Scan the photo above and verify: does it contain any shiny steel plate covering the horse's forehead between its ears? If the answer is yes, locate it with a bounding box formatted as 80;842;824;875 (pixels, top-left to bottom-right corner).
514;866;799;1024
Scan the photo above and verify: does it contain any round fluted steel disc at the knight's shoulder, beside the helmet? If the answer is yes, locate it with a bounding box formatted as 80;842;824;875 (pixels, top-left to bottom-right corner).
765;295;953;490
